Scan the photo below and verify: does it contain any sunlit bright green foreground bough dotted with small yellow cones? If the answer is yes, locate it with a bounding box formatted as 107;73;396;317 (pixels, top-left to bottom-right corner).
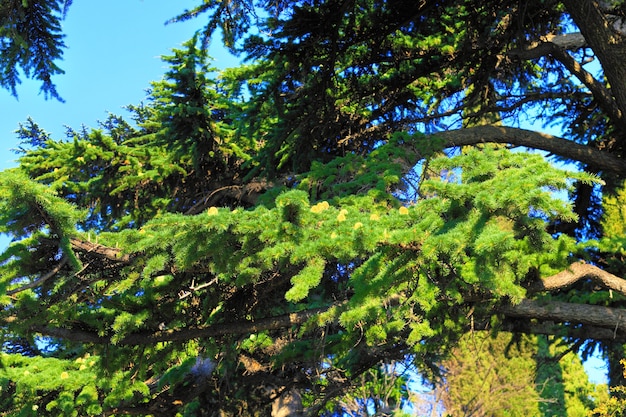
4;135;592;412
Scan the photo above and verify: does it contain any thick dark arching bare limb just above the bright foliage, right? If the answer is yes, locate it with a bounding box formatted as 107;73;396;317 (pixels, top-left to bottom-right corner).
433;126;626;174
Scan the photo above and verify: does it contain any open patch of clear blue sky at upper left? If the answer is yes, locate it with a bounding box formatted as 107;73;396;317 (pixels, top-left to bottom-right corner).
0;0;237;169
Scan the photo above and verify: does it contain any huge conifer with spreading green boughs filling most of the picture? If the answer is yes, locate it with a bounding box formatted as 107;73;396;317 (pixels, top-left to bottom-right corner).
0;0;626;416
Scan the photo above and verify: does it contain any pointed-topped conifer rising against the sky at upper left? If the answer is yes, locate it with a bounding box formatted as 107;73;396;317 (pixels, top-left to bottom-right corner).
20;39;252;230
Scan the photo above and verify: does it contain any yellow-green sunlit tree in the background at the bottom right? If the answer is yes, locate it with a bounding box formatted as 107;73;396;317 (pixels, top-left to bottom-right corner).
436;332;606;417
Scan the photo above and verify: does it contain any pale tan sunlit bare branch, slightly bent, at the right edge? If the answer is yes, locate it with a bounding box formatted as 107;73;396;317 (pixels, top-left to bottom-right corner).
528;261;626;295
